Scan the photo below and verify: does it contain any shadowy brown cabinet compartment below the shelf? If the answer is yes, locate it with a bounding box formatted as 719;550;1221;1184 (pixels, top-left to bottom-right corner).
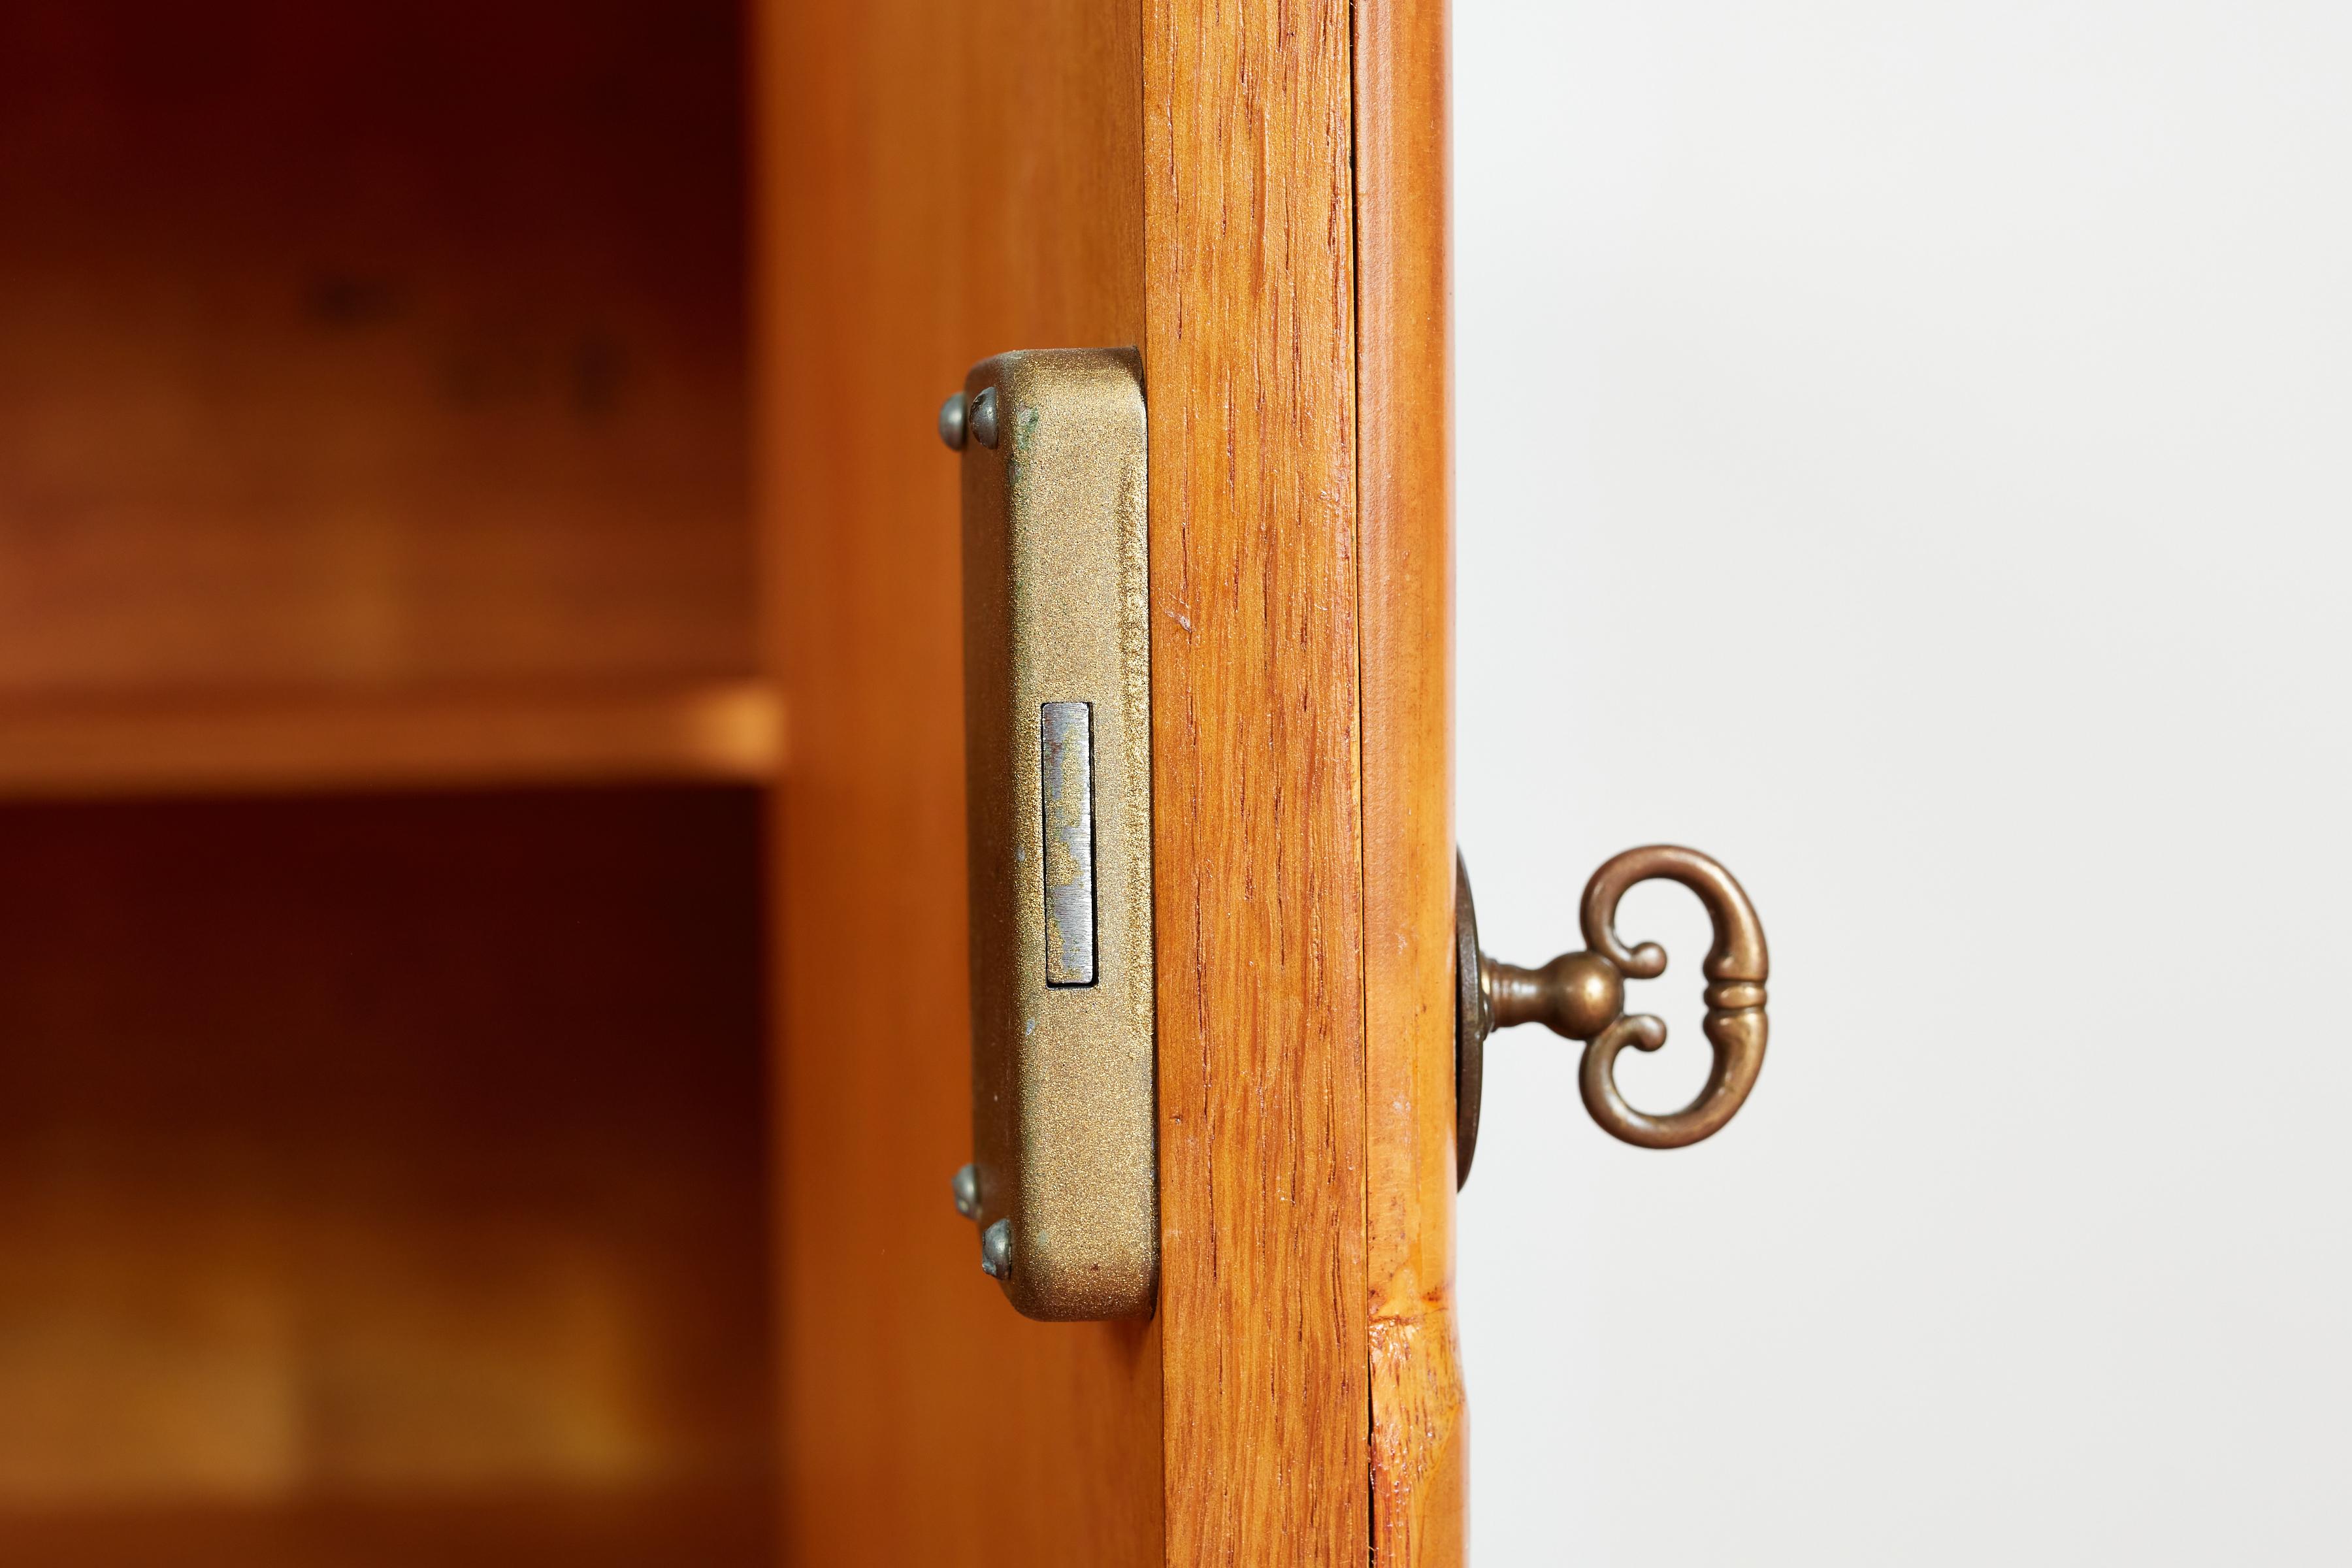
0;790;774;1568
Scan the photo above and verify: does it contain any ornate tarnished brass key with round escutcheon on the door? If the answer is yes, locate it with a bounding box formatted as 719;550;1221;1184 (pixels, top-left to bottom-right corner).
1456;844;1771;1175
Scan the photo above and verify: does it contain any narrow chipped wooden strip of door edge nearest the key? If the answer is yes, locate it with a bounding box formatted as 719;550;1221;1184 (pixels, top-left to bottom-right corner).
1355;0;1465;1568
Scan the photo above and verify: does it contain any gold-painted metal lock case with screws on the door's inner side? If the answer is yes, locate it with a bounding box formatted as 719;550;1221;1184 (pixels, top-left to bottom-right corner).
941;348;1160;1319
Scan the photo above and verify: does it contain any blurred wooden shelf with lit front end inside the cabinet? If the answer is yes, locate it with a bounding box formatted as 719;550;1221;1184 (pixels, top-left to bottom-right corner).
0;679;783;799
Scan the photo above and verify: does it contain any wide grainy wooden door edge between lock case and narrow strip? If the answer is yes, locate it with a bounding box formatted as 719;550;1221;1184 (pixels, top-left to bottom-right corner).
1143;0;1369;1563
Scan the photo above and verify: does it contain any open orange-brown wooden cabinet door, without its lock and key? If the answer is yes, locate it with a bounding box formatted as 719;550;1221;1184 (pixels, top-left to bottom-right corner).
753;0;1463;1565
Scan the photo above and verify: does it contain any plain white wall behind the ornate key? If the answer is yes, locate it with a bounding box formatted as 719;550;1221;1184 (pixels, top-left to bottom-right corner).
1456;0;2352;1568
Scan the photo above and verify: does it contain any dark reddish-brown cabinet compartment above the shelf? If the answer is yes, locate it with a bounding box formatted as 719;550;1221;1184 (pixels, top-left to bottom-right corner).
0;0;753;698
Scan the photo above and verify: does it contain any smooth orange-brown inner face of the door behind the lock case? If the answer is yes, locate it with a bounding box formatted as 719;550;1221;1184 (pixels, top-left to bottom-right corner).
757;0;1162;1568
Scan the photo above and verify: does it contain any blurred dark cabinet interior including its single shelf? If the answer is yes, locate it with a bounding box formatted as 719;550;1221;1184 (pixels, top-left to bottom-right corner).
0;0;781;1565
